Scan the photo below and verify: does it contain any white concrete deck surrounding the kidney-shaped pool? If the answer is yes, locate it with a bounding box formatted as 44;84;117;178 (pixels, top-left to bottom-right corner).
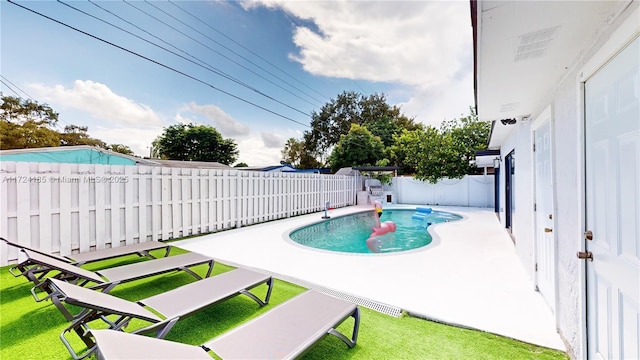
173;206;566;351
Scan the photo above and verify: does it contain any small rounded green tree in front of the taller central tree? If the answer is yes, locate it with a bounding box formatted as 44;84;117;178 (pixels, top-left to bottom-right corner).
329;124;384;171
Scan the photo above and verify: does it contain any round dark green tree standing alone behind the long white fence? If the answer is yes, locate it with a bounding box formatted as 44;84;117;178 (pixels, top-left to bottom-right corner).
153;124;238;165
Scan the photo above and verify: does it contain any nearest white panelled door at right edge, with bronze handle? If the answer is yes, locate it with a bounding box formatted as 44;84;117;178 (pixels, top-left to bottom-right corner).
585;38;640;359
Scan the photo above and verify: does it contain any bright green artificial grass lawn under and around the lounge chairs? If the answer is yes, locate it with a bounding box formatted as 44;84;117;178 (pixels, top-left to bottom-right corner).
0;248;568;360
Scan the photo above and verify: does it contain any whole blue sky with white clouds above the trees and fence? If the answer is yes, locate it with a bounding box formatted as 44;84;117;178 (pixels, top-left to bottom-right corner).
0;0;474;166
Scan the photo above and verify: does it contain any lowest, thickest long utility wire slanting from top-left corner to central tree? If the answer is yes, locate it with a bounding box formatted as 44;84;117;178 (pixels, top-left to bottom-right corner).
7;0;310;128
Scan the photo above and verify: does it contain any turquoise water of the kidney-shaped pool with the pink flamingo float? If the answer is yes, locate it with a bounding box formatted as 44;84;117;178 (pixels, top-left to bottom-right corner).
289;209;462;253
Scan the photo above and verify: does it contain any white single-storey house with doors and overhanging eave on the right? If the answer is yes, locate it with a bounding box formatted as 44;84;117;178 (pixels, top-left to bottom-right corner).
471;0;640;359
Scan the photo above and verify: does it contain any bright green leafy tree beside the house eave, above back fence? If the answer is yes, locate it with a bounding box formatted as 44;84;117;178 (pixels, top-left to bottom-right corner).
390;110;491;183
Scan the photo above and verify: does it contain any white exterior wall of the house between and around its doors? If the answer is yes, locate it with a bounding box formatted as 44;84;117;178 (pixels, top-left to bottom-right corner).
492;2;640;359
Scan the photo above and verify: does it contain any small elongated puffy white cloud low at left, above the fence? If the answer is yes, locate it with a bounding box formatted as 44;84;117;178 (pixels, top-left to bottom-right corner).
30;80;162;126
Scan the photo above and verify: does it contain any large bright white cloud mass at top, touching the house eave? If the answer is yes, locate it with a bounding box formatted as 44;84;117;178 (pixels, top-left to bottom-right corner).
243;0;474;125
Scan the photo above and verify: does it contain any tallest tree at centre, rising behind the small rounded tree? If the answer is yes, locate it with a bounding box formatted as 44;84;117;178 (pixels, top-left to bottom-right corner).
304;92;417;163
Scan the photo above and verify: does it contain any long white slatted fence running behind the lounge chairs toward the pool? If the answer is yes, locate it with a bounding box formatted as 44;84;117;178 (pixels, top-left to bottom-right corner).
0;162;355;266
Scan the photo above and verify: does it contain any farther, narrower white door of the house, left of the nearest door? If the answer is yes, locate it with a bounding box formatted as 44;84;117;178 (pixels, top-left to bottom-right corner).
534;117;556;312
